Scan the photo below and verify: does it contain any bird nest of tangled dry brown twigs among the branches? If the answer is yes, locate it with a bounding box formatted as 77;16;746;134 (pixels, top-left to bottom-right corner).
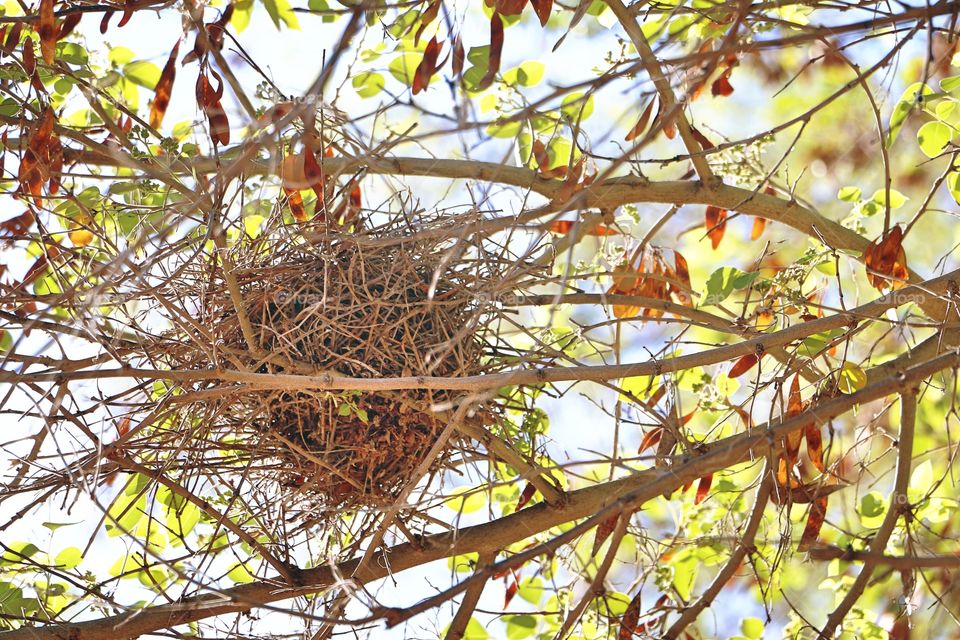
156;215;516;514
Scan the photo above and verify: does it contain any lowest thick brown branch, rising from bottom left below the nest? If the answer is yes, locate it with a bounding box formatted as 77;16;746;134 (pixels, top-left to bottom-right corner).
0;352;960;640
